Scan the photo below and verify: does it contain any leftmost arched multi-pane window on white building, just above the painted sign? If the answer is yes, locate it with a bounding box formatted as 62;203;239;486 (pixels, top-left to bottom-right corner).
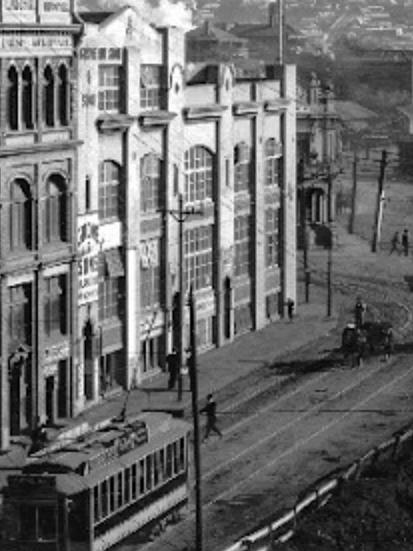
99;161;121;221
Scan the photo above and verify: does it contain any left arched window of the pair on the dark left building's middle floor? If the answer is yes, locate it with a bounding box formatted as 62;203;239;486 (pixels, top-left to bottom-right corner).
9;179;32;251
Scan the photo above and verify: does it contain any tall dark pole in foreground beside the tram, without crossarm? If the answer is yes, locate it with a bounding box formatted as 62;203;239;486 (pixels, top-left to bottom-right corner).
189;286;203;551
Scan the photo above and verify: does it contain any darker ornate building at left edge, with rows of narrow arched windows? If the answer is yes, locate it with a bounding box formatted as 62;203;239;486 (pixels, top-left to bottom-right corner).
0;0;80;449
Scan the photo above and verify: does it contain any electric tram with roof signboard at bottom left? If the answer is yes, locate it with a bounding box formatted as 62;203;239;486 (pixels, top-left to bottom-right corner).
0;413;190;551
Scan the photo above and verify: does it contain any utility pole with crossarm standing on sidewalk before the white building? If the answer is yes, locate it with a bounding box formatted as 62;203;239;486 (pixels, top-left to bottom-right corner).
161;193;203;401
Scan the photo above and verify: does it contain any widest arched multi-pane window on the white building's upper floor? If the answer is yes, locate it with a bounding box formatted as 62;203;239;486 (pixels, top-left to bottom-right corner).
185;146;214;203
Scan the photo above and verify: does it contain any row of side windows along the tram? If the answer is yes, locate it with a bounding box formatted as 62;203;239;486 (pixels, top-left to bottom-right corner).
93;438;186;523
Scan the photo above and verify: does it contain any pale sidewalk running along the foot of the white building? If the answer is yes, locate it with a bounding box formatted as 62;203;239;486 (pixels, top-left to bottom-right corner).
64;292;337;436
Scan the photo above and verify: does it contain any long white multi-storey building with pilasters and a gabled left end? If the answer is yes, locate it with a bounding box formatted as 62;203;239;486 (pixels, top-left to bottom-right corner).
75;8;296;398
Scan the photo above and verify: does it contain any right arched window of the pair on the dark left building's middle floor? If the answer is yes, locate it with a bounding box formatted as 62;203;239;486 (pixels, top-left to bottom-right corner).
43;174;68;243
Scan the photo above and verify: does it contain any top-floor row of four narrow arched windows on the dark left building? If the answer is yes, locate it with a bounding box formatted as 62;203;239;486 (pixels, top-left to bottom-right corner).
7;64;71;130
